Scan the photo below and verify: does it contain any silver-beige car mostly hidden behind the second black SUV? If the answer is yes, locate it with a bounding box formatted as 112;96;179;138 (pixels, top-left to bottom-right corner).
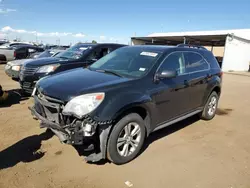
5;50;65;80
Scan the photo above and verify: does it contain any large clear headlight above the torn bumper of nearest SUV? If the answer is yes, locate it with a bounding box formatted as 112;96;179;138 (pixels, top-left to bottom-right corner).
63;93;105;119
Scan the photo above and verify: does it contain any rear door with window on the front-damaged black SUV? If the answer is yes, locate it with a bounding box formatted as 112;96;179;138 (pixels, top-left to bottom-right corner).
184;51;211;110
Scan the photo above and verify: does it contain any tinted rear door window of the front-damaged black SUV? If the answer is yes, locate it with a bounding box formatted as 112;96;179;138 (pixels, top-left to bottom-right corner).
185;52;209;72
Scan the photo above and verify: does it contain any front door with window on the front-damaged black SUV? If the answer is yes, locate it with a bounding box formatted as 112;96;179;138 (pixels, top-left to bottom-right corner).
153;52;190;124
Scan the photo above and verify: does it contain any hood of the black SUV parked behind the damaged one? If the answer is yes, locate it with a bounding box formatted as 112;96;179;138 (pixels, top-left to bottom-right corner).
25;57;69;67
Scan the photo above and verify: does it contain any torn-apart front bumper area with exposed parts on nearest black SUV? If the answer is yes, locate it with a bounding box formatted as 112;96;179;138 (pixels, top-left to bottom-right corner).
29;95;111;162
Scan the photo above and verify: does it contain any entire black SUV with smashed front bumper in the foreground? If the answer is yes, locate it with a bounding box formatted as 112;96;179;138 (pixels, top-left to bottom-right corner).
30;45;222;164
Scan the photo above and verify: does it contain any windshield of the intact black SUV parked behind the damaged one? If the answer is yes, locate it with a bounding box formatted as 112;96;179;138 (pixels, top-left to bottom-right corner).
56;44;92;59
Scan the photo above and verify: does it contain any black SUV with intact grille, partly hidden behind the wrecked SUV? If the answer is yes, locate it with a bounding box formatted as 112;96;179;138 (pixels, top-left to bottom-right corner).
19;43;125;93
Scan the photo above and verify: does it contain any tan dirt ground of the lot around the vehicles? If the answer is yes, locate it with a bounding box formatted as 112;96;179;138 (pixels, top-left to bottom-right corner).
0;65;250;188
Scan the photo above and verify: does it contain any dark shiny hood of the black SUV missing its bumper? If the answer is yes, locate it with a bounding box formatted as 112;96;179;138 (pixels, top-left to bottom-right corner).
37;68;132;102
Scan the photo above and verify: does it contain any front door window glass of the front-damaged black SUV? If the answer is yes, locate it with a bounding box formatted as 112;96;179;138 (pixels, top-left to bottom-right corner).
159;52;186;75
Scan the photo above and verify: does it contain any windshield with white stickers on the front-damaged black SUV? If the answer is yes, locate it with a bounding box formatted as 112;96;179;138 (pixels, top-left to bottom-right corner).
90;47;161;78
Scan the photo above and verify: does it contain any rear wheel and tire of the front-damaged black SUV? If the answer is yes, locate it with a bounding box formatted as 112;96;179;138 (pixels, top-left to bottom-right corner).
201;91;219;120
